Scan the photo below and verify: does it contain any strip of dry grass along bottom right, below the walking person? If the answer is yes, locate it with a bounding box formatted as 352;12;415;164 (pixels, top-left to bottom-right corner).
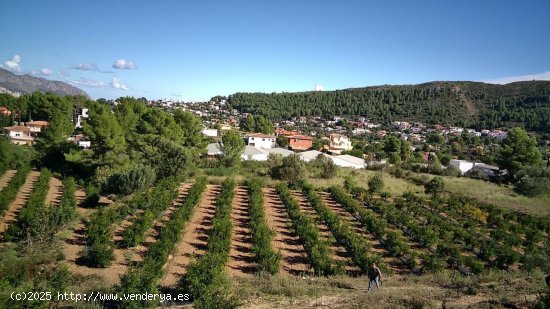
235;271;545;308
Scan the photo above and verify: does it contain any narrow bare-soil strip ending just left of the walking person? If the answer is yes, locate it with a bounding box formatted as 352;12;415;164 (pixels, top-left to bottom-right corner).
292;191;360;275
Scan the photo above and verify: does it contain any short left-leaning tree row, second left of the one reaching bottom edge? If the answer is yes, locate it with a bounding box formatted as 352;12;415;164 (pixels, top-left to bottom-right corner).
122;177;181;247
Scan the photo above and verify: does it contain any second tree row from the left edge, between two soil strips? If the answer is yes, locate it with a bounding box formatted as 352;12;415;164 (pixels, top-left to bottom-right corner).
6;169;52;241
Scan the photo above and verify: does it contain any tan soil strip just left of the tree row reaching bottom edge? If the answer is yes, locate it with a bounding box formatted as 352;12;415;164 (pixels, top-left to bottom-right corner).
160;185;221;287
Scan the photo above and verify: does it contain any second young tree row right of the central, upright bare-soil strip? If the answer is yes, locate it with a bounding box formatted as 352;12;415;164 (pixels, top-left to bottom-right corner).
277;183;335;275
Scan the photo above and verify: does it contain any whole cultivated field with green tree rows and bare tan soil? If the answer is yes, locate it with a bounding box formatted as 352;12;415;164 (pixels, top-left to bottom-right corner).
0;171;550;308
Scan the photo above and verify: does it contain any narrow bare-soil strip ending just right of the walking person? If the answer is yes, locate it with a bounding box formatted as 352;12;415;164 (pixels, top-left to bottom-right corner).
318;192;409;274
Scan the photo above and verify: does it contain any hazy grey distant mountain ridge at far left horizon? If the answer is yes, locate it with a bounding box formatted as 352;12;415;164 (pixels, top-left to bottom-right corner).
0;69;90;98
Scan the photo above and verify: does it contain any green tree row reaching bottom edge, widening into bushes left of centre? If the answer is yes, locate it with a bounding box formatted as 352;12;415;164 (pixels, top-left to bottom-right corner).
181;179;237;308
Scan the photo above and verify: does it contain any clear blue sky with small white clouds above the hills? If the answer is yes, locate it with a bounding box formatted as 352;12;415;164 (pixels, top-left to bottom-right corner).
0;0;550;101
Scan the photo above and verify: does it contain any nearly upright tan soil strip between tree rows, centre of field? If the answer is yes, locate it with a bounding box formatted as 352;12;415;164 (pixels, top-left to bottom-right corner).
226;187;256;277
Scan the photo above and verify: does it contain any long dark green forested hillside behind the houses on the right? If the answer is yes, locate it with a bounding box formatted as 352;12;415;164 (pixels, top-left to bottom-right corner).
229;81;550;131
